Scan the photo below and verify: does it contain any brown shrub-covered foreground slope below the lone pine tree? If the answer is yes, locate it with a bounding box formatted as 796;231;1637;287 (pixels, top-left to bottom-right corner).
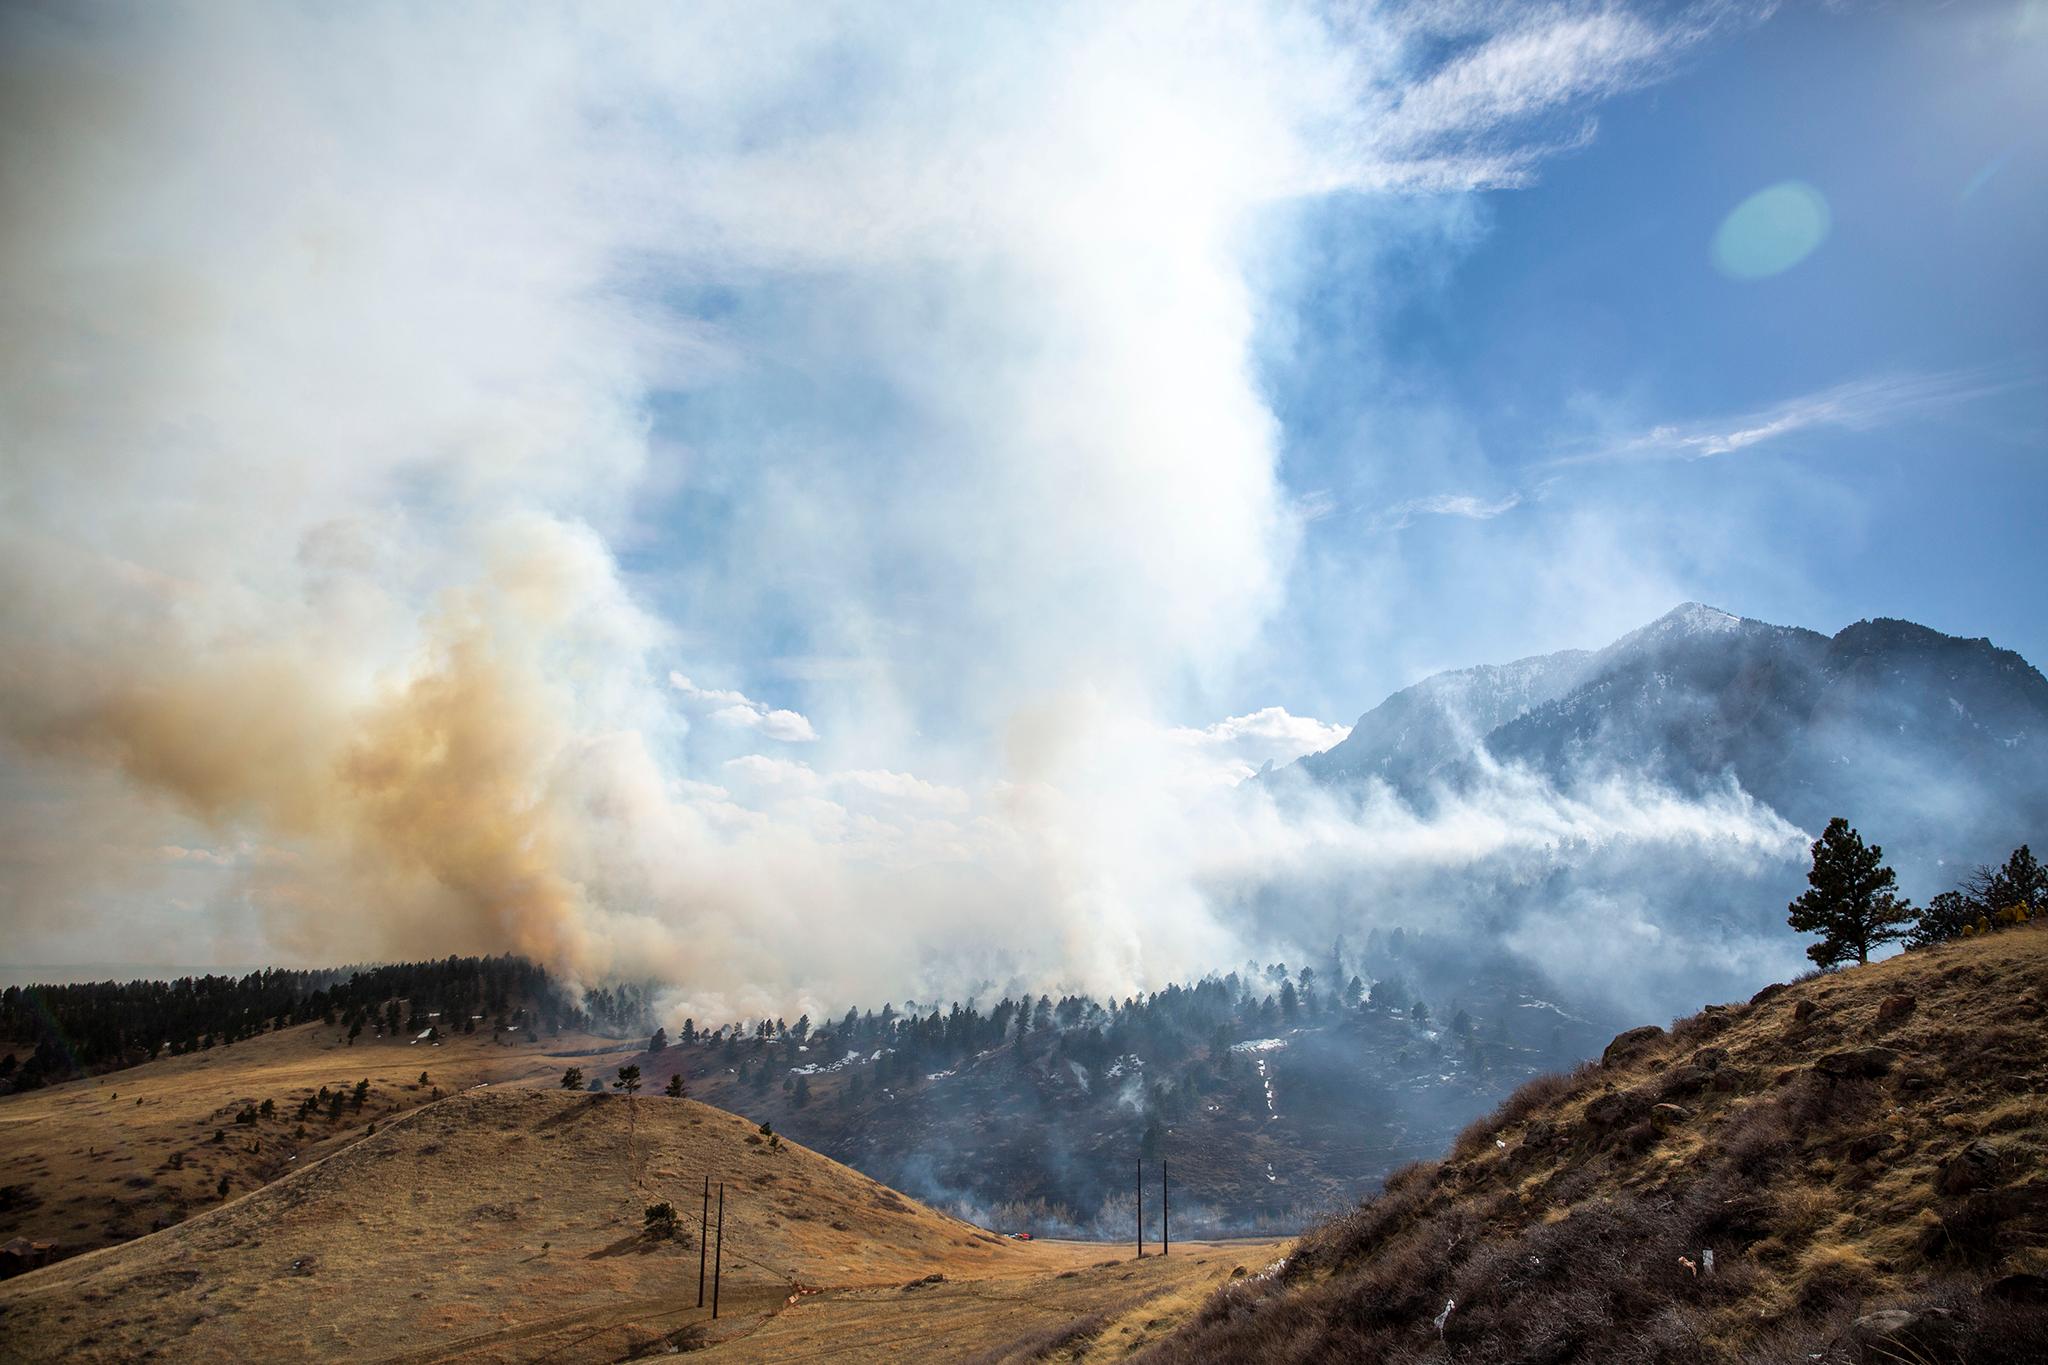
1143;927;2048;1365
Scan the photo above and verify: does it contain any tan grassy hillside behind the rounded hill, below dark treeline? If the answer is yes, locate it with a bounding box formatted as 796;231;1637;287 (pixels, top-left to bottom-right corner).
0;1023;631;1254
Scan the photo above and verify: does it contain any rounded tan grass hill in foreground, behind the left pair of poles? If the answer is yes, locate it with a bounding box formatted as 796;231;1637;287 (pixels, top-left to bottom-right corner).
0;1089;1038;1361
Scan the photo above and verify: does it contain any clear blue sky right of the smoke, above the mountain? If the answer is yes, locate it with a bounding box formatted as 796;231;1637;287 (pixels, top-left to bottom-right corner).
1262;4;2048;714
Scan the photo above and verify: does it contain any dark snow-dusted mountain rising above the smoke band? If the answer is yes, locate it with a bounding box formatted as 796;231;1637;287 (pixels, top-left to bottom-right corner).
1276;602;2048;888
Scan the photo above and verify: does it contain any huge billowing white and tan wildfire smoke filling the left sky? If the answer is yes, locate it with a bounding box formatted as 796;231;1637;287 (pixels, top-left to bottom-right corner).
0;4;1778;1017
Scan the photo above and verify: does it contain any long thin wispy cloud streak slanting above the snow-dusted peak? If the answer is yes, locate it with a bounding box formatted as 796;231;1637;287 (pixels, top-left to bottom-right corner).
1552;366;2042;465
